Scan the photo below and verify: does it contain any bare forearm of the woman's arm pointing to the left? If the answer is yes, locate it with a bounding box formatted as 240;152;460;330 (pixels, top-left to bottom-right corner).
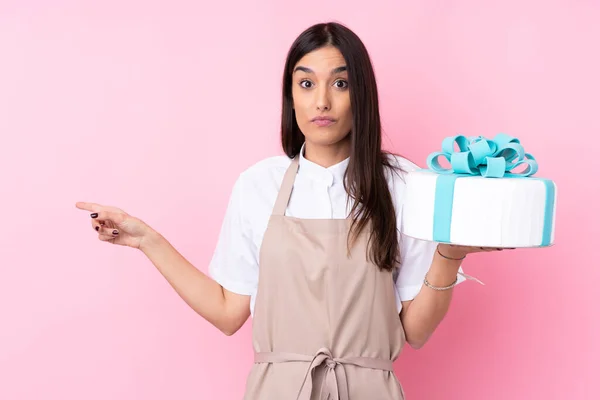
140;231;237;334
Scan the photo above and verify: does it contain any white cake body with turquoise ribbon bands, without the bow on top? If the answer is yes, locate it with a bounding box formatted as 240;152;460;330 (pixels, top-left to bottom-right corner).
401;136;556;248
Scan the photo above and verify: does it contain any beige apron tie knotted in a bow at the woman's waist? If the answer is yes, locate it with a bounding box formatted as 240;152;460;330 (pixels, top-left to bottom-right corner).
254;347;393;400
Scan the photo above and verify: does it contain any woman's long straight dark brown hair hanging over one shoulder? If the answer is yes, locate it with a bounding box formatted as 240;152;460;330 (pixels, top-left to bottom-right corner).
281;22;400;270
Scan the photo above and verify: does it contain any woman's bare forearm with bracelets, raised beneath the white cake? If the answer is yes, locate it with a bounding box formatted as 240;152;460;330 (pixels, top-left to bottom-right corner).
402;244;460;348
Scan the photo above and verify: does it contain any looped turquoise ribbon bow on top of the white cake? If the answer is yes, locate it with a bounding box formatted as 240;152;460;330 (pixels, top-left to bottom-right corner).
427;133;538;178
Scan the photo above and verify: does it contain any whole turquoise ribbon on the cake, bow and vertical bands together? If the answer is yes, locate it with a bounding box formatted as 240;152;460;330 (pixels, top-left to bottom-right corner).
427;133;555;246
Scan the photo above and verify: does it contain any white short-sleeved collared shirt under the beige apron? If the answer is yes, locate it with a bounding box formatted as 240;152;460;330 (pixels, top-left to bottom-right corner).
209;147;465;315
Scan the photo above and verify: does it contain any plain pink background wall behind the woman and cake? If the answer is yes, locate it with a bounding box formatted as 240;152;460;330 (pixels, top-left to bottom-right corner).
0;0;600;400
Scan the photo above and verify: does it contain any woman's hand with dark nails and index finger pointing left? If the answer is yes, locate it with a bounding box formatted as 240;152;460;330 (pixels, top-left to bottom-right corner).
75;202;152;249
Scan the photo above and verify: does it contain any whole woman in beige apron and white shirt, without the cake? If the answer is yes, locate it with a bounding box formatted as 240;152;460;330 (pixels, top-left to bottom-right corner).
77;23;491;400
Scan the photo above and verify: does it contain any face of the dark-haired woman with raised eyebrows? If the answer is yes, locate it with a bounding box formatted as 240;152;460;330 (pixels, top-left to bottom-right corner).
292;46;352;150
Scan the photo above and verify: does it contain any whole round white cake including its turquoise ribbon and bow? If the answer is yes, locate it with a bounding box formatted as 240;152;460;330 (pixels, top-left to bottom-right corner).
401;134;556;248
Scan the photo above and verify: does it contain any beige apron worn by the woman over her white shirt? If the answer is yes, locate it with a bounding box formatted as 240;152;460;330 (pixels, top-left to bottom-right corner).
244;157;405;400
